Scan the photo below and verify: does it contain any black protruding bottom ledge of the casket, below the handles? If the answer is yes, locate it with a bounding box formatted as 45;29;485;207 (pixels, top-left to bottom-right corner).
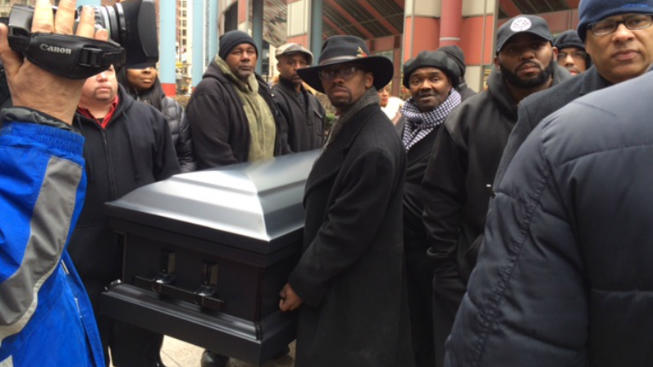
102;283;296;365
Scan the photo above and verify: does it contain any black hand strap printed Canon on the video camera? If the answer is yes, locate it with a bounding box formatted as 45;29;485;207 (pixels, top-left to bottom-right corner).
9;30;125;79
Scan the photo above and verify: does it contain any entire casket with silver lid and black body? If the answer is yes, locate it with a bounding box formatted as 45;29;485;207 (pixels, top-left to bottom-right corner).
101;152;318;364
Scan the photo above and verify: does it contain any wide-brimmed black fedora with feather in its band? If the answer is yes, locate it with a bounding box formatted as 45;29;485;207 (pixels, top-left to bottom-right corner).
297;36;394;93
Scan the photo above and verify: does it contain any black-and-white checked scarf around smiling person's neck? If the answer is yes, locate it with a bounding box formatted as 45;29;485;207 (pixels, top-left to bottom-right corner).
401;88;460;151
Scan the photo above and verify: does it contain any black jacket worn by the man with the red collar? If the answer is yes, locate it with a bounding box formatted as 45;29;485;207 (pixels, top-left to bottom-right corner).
69;86;179;282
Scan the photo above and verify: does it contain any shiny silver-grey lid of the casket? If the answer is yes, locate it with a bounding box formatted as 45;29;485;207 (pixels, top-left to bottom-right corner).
107;150;319;250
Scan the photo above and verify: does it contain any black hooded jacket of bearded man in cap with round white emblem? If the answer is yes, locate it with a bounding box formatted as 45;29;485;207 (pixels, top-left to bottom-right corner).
423;64;571;279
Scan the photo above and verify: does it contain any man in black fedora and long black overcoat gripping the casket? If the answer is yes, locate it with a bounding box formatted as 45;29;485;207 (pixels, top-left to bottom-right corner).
279;36;413;367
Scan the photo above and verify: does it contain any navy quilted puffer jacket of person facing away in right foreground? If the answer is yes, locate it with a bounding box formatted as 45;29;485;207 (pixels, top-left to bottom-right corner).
446;71;653;367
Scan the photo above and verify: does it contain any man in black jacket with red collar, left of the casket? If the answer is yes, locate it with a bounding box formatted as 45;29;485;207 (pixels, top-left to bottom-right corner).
69;67;179;367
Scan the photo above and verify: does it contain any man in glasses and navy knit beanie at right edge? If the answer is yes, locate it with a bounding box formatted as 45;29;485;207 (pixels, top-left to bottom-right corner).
494;0;653;186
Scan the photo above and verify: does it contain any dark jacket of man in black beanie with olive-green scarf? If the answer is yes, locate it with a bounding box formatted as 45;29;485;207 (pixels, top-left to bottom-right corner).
186;60;289;169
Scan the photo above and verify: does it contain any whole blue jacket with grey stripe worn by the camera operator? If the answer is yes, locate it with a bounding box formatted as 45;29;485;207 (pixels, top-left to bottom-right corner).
0;119;104;367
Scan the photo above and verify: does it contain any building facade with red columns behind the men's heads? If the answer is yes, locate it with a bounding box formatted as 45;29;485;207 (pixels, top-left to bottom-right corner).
219;0;579;94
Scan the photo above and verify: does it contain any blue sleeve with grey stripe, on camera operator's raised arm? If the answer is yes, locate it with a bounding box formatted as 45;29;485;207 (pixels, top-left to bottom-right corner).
0;122;86;341
